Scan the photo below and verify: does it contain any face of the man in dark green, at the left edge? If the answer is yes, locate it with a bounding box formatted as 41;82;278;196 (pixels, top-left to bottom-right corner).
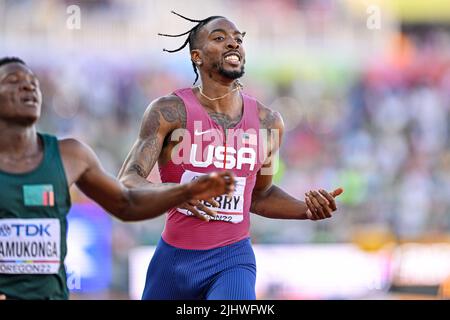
0;63;42;125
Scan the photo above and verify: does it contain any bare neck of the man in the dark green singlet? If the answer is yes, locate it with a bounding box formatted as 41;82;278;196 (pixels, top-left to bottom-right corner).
0;121;39;155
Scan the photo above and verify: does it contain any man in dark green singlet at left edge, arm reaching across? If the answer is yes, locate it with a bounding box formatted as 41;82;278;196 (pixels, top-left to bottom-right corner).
0;58;234;299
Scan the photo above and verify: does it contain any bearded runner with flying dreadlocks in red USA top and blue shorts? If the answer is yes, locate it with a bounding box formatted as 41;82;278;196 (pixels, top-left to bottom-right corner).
119;13;342;299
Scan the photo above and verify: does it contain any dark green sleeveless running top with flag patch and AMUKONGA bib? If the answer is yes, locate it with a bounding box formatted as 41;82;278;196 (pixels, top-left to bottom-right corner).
0;134;71;299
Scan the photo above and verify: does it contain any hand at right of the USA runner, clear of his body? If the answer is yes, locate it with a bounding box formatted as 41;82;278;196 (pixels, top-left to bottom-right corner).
305;188;344;220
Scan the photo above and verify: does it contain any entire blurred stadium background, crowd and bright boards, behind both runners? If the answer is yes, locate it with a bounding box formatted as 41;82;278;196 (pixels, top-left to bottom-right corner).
0;0;450;299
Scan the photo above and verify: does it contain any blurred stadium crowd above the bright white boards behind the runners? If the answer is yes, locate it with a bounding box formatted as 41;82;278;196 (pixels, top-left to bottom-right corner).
0;0;450;298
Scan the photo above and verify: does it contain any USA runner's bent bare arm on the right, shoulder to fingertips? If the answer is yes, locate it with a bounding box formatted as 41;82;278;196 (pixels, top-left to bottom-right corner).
250;105;343;220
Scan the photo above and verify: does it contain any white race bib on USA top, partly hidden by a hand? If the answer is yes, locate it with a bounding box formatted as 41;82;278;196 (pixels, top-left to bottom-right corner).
177;170;246;223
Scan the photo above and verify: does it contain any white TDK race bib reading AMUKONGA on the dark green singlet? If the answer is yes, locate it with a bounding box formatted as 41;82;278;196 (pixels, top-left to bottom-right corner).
0;219;61;274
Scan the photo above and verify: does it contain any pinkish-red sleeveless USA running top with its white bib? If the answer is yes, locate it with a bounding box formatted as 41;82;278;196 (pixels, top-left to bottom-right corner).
160;88;262;250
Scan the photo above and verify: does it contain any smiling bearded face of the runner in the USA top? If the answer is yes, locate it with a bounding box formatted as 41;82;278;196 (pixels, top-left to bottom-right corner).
191;18;245;80
